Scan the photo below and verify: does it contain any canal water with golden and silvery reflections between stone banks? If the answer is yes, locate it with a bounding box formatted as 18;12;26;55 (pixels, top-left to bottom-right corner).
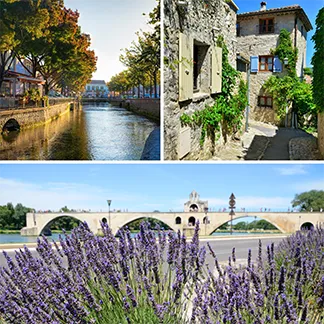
0;103;160;160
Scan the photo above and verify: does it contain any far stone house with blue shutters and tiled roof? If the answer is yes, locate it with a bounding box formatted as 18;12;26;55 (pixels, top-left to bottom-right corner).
236;1;312;126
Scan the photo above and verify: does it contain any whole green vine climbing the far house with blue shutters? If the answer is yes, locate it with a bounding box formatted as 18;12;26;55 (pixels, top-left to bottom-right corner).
263;29;317;130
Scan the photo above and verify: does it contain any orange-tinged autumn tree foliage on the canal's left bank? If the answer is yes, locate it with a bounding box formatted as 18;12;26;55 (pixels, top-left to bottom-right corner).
0;0;96;94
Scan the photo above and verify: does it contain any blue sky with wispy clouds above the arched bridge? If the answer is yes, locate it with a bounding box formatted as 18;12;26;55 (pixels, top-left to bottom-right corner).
0;164;324;212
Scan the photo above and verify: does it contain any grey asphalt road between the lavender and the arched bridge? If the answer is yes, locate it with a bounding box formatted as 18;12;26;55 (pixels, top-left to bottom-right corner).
0;236;285;267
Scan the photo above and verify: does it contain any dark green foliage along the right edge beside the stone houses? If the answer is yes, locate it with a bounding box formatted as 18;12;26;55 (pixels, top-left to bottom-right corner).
312;8;324;112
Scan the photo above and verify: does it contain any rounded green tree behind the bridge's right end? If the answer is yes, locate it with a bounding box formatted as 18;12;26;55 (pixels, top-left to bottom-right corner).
291;190;324;211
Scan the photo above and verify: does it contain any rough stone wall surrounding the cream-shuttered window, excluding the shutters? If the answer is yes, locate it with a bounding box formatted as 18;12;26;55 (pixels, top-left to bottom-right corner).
163;0;236;160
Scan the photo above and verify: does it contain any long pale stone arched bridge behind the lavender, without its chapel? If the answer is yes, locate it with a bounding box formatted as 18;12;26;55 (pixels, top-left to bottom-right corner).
21;211;324;236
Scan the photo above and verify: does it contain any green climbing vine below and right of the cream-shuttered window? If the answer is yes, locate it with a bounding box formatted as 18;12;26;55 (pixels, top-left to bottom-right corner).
180;37;248;145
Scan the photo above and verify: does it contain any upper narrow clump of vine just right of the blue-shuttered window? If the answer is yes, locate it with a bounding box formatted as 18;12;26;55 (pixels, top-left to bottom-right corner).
273;29;298;77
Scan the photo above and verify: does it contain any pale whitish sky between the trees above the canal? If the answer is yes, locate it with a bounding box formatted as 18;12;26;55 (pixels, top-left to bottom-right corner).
64;0;156;82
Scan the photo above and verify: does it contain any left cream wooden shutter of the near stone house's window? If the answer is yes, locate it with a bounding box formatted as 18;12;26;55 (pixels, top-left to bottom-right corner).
179;33;193;101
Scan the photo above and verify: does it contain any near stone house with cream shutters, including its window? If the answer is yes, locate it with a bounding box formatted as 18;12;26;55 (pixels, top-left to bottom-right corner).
163;0;238;160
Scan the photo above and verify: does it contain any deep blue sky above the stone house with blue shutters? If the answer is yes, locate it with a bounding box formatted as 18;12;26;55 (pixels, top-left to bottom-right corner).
234;0;324;66
